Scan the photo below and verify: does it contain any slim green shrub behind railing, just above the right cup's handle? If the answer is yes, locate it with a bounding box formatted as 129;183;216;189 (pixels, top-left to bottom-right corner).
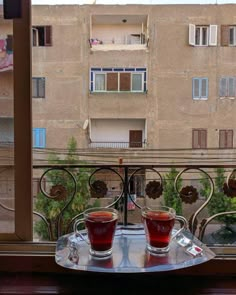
163;167;182;215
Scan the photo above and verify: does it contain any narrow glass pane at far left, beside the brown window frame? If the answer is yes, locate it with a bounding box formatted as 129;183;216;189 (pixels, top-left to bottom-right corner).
0;4;15;234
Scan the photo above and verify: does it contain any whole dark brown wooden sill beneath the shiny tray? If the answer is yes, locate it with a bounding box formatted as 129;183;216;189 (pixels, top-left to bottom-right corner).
0;255;236;295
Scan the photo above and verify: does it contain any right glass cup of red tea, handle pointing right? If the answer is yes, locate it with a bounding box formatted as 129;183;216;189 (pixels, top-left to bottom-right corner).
142;206;187;255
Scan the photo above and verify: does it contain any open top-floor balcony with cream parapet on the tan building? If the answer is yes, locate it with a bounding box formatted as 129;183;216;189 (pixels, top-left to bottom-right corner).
89;15;148;51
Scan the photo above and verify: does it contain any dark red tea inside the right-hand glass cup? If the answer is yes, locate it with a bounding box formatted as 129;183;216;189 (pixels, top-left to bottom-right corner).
143;211;175;248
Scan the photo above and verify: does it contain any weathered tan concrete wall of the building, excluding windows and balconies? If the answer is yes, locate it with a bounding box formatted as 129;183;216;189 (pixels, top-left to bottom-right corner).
32;5;236;158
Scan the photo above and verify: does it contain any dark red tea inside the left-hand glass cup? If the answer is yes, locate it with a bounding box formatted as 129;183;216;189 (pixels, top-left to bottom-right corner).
85;211;117;251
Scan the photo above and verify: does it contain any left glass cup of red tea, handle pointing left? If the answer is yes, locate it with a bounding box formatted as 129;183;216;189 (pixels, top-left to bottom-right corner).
74;207;118;258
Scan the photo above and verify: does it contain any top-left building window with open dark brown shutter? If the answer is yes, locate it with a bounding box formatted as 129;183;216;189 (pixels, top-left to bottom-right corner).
32;26;52;46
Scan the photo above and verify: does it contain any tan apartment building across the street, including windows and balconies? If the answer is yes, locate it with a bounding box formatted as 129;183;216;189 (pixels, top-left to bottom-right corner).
32;5;236;152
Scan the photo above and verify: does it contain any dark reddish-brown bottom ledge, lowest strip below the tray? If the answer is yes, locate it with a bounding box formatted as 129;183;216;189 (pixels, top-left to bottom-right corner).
0;273;236;295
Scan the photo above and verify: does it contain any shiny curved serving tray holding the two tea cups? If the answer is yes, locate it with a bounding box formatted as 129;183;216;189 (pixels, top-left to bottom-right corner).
55;225;215;273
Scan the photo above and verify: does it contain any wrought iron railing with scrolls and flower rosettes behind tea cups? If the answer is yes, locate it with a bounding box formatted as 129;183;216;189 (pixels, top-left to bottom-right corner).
0;164;236;251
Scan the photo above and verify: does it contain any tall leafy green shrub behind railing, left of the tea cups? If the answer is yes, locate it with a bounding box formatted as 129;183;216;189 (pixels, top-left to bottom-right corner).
34;137;99;240
